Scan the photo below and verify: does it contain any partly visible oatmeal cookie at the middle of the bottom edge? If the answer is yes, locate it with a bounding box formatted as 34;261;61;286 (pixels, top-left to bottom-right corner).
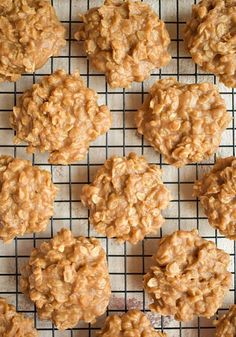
97;310;167;337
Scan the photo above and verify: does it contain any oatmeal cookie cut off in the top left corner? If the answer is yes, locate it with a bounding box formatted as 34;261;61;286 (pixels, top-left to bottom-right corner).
0;0;66;82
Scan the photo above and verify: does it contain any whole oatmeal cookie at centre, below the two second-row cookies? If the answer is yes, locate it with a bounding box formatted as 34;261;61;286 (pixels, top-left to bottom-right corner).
81;153;170;244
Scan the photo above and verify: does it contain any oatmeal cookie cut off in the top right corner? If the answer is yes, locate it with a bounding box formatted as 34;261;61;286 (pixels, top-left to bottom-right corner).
184;0;236;87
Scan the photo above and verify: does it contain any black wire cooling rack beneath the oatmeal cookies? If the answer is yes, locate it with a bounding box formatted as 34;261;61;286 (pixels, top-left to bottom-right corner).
0;0;236;337
